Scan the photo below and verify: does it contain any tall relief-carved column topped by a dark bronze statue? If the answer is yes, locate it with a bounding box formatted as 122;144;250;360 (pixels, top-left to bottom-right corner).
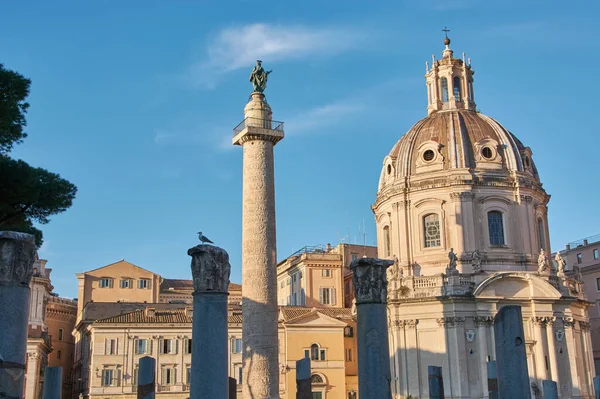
233;61;283;399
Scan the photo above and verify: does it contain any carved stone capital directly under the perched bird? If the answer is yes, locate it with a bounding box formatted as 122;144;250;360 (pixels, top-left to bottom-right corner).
188;244;231;293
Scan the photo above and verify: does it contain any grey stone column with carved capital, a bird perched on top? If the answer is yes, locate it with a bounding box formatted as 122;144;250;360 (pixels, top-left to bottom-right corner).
188;244;231;399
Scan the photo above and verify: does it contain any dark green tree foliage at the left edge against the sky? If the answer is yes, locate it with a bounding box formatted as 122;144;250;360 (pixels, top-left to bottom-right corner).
0;64;77;246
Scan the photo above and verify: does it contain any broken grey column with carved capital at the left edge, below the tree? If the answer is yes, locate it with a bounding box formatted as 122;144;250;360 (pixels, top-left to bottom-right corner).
0;231;37;398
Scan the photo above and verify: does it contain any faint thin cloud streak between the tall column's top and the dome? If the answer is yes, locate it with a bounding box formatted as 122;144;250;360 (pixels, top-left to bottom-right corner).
285;101;365;135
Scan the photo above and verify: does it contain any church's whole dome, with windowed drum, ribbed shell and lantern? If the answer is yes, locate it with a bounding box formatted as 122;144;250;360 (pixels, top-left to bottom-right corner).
372;39;550;275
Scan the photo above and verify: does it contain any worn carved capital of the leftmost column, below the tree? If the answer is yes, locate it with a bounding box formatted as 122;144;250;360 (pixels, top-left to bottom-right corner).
0;231;37;287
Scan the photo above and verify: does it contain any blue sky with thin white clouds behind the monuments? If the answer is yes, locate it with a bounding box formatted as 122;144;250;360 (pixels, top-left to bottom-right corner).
0;0;600;297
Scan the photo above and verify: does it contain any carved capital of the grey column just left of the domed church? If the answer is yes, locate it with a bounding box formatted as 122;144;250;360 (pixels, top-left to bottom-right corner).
350;258;394;305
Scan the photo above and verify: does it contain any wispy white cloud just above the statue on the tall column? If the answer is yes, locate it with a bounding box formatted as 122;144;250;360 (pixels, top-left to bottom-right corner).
185;24;366;87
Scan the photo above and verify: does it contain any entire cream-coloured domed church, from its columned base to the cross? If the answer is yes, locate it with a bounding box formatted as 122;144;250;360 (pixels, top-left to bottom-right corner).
372;38;595;398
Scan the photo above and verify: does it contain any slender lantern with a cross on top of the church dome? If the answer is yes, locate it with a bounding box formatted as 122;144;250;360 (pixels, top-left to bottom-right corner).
425;28;475;114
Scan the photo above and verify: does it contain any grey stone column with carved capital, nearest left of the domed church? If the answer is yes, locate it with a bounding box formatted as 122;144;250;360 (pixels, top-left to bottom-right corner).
350;258;394;399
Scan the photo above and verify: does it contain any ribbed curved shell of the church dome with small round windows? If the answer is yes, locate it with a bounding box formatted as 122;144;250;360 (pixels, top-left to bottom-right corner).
379;109;539;190
